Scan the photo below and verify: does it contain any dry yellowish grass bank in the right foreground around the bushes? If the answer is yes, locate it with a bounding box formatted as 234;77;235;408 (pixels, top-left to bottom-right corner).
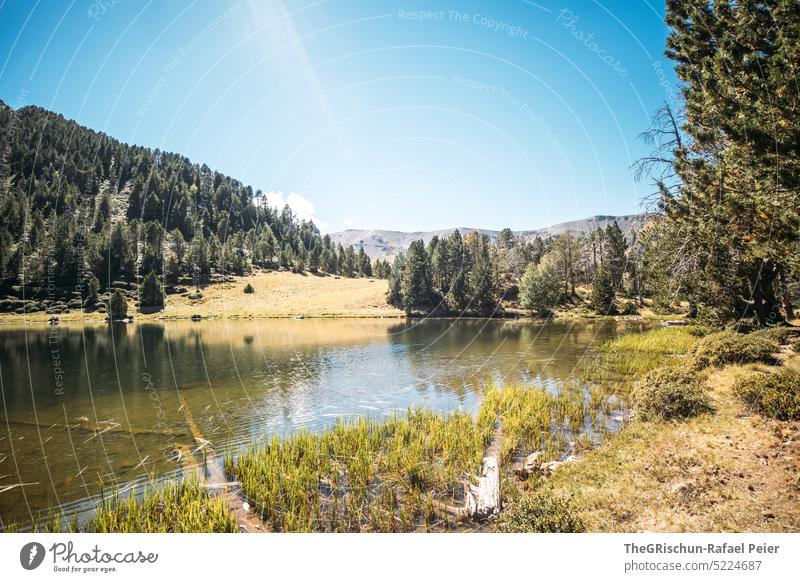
547;357;800;532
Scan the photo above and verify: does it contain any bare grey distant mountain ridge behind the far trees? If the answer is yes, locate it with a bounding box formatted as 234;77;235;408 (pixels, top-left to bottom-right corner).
330;213;651;260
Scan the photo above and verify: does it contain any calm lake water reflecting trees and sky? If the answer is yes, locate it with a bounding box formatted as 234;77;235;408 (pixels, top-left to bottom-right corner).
0;319;639;525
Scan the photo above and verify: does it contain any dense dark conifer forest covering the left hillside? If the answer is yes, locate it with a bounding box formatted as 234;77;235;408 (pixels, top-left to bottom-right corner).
0;102;389;314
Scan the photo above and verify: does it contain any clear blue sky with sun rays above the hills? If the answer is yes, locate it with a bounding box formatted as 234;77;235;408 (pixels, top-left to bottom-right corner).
0;0;677;231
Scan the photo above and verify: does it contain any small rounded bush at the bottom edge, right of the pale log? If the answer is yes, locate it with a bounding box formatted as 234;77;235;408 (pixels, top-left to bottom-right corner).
495;493;586;533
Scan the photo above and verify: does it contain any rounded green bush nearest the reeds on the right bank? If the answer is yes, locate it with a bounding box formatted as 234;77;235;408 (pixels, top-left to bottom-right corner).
633;366;714;420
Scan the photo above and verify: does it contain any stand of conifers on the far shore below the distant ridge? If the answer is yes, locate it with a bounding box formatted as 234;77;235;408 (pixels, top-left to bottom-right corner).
388;222;645;316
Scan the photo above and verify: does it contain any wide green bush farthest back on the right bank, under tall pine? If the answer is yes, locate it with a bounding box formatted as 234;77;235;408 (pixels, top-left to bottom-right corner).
689;331;780;370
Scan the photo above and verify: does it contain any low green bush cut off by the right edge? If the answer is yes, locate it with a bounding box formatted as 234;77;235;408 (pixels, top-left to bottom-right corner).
733;368;800;420
